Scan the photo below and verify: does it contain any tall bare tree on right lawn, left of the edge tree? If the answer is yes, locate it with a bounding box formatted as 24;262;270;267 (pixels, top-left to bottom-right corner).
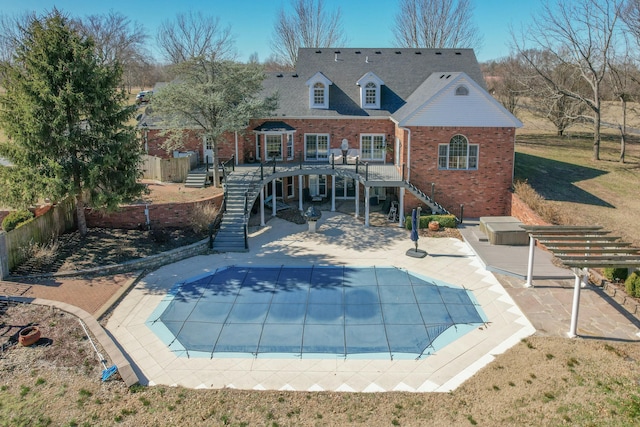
514;0;623;160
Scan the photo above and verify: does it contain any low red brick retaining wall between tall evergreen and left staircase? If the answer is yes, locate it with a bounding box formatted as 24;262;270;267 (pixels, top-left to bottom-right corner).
86;194;223;230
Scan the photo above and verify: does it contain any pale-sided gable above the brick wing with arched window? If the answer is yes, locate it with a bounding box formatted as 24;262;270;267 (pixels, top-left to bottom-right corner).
391;72;522;128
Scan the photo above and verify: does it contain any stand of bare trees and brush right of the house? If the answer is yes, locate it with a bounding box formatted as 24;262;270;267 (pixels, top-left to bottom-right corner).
484;0;640;162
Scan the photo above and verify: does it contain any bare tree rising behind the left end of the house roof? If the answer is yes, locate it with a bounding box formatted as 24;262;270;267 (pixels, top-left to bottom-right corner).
271;0;347;68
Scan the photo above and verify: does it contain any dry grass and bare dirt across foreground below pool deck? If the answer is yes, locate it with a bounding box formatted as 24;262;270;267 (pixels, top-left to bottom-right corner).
0;306;640;426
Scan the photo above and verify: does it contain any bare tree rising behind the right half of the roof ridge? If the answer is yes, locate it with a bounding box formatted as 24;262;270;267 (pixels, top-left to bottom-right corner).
393;0;482;48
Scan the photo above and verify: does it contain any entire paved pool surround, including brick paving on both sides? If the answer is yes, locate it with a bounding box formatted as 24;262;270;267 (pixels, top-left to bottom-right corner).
5;211;640;392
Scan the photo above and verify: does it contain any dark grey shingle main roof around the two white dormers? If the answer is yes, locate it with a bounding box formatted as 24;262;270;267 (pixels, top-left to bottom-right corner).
263;48;485;117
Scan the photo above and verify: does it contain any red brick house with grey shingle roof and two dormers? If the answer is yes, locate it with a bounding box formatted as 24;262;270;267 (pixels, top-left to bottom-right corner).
141;48;522;217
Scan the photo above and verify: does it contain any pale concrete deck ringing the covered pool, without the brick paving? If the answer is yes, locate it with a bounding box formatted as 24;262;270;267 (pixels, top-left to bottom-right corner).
102;211;548;392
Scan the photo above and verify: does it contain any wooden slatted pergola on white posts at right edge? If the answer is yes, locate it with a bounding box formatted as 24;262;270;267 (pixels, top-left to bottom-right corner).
521;225;640;338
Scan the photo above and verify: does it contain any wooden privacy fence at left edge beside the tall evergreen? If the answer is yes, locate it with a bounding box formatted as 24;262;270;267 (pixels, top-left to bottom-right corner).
0;198;75;278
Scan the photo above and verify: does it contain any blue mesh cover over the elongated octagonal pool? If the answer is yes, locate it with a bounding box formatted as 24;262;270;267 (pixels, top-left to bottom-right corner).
147;266;486;359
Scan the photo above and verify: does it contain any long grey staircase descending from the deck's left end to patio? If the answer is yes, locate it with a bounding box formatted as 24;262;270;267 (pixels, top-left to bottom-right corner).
212;168;256;252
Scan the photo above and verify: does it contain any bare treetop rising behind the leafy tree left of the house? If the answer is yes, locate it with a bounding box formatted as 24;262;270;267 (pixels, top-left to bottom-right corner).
156;12;235;64
